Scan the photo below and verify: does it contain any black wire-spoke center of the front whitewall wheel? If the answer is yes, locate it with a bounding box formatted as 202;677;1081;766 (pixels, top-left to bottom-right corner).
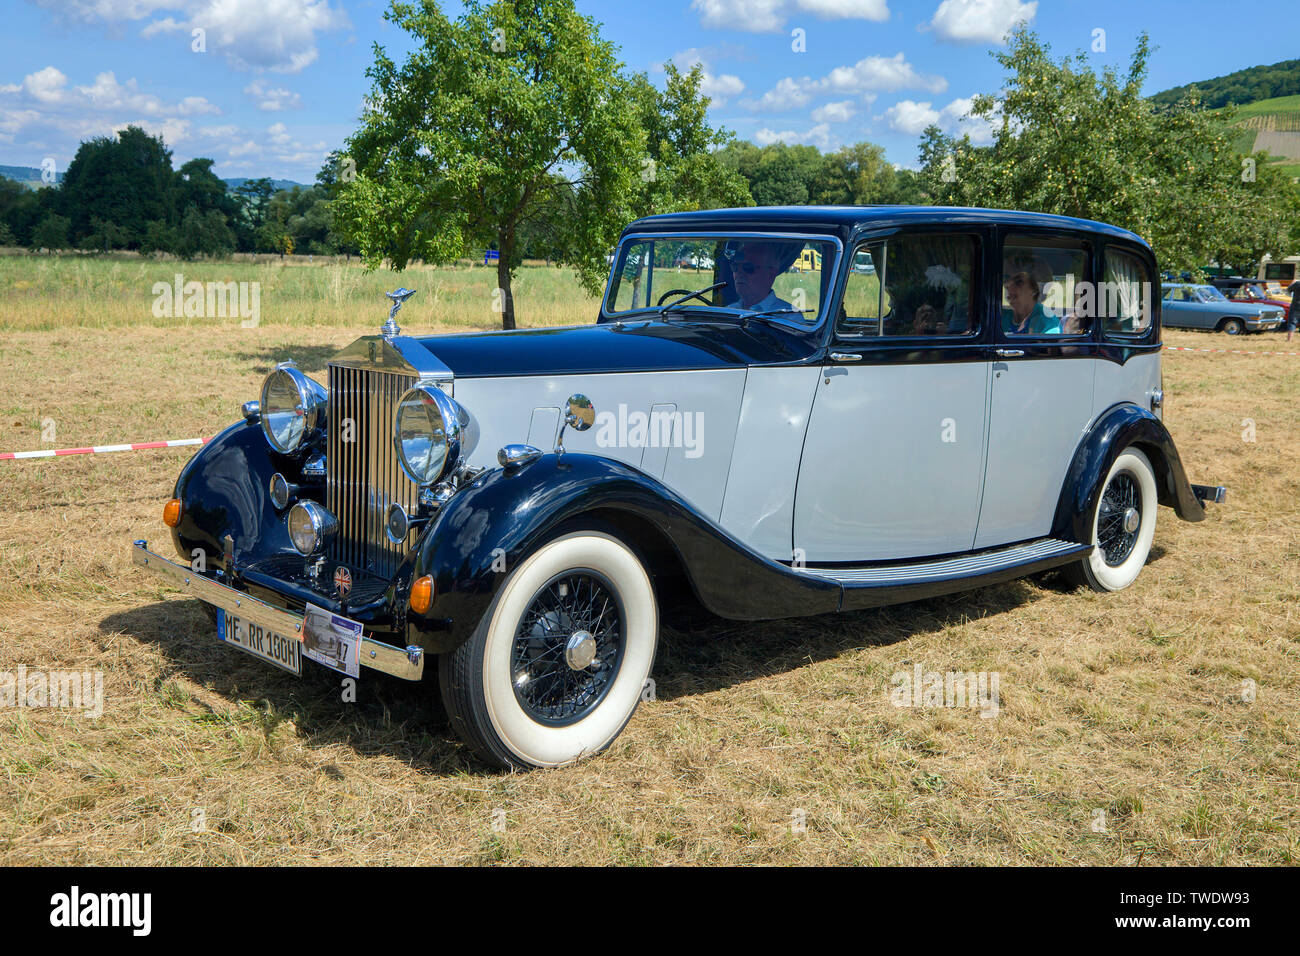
511;568;625;726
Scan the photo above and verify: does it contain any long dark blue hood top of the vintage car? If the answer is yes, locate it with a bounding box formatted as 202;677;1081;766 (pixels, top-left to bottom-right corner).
419;319;819;378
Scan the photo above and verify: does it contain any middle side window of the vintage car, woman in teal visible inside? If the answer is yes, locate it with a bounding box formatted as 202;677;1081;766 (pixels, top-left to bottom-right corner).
1002;235;1096;336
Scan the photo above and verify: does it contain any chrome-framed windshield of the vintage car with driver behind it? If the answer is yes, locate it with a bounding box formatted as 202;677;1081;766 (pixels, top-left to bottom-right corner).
605;234;836;325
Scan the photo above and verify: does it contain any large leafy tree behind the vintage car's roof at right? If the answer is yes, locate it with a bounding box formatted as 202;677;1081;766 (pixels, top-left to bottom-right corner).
920;29;1286;268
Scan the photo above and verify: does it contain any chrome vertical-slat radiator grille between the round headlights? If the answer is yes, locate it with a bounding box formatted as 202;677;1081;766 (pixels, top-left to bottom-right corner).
326;365;420;576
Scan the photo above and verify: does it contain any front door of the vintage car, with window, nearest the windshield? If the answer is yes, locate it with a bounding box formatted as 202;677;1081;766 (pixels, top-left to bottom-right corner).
793;230;989;563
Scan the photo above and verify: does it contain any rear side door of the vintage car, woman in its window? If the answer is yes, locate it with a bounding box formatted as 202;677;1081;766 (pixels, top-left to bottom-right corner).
975;230;1096;549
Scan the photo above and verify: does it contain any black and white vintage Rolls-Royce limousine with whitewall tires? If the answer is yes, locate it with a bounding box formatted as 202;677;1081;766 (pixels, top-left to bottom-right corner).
133;207;1223;767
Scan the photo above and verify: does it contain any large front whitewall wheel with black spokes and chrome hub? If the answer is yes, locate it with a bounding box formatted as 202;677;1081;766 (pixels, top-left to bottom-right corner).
438;531;659;769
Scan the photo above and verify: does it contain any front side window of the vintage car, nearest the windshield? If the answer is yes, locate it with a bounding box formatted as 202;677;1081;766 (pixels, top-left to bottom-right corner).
840;234;976;337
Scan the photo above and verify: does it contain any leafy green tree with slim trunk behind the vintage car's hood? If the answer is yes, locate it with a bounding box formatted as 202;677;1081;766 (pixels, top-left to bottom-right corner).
334;0;645;329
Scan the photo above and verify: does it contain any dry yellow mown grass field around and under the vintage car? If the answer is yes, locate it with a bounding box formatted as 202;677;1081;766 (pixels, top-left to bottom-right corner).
0;259;1300;865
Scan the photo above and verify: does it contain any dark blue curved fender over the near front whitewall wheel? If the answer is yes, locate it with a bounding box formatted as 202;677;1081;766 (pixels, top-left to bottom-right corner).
410;451;840;653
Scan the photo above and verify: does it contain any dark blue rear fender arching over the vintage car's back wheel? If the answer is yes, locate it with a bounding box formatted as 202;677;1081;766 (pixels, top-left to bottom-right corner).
1052;403;1205;544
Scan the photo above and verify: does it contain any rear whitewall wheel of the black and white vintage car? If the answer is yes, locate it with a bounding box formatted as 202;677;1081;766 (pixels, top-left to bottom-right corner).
1065;447;1160;592
